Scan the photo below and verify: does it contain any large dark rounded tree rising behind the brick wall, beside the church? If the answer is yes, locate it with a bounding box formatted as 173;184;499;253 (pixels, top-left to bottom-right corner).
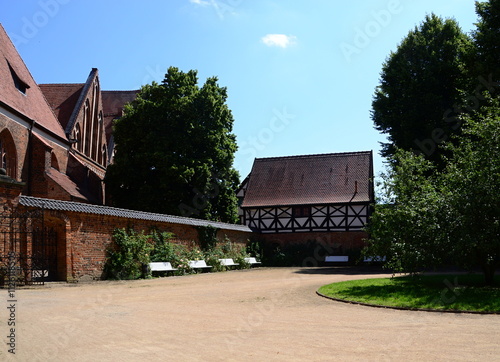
105;67;239;222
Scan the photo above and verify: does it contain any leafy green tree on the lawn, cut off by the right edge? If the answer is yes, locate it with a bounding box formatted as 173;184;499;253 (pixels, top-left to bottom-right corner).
443;102;500;284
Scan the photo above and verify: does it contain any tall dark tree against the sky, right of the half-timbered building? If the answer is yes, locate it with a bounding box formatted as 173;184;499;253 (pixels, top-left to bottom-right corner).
371;14;472;161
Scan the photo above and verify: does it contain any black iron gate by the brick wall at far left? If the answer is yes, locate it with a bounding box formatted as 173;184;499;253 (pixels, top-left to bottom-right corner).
0;209;57;286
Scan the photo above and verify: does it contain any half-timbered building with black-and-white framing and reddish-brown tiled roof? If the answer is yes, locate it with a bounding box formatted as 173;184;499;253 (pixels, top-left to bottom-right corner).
239;151;374;248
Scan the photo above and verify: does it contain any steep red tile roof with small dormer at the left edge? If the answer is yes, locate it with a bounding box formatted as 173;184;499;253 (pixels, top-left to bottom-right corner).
0;24;66;139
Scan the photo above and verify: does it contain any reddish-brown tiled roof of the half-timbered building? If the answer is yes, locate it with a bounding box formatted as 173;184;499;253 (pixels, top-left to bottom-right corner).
242;151;373;207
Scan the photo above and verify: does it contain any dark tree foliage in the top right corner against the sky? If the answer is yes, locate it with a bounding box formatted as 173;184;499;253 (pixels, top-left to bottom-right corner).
472;0;500;82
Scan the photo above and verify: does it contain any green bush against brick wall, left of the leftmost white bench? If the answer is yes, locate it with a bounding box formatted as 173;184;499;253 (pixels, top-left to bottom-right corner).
104;229;153;280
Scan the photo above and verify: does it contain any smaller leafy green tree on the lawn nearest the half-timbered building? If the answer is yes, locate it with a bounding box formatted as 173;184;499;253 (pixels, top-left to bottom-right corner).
365;149;449;273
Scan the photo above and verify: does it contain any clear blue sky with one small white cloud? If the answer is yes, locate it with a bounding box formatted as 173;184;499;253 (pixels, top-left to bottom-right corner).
0;0;477;178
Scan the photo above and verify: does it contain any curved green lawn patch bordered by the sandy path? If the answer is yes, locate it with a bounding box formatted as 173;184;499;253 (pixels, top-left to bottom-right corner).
318;274;500;313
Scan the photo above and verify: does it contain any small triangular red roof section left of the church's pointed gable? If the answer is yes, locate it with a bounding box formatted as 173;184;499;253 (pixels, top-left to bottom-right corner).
39;83;85;129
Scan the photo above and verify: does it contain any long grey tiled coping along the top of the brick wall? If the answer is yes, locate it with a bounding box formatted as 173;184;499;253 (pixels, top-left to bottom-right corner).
19;196;251;232
